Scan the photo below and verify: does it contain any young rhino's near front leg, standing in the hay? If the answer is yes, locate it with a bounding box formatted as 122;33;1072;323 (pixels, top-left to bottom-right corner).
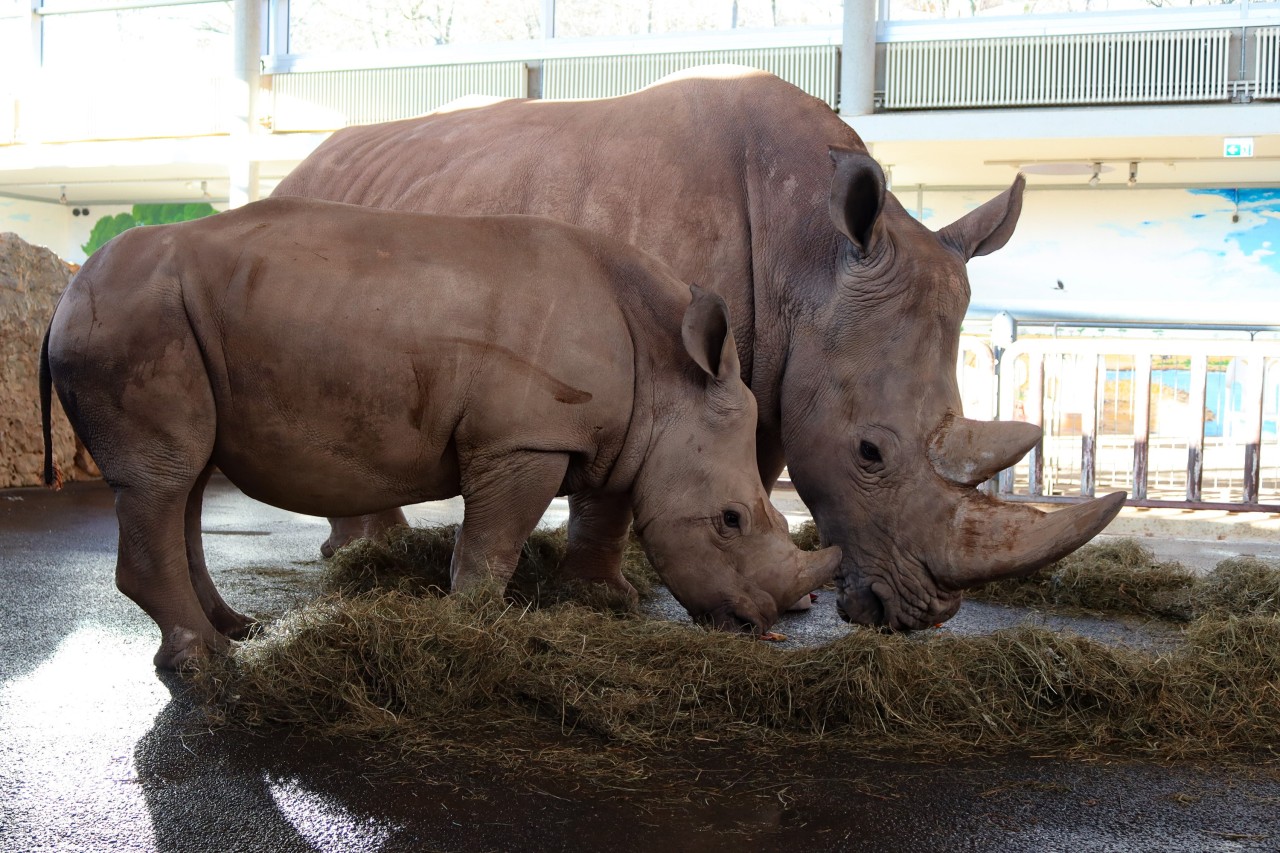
449;451;568;592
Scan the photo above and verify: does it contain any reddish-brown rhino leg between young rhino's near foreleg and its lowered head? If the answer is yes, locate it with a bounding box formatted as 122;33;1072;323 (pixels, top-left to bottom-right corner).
559;492;640;606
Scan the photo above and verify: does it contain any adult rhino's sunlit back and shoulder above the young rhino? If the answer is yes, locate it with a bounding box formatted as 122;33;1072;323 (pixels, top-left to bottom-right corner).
275;67;864;417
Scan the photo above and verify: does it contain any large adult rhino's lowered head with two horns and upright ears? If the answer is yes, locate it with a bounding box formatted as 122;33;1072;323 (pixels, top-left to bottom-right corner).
782;149;1125;630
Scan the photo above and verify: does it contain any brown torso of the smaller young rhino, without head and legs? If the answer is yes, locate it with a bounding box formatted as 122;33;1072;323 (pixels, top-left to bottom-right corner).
170;199;660;514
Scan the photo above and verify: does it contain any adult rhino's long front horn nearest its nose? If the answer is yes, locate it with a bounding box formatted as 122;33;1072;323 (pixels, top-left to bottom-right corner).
937;492;1128;589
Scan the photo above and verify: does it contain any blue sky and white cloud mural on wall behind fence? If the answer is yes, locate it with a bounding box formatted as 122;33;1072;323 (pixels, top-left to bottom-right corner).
922;187;1280;325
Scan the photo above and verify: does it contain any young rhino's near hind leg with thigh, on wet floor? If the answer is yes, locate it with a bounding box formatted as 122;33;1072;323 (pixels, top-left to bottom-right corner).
60;312;227;669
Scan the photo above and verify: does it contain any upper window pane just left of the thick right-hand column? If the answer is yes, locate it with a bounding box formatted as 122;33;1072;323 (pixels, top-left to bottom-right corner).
556;0;844;37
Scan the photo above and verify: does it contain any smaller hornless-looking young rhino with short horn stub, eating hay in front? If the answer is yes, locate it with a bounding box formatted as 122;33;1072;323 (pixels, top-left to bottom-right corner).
41;199;840;667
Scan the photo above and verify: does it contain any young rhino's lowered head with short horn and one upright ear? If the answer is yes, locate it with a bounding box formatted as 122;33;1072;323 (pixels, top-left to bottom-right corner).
634;286;840;633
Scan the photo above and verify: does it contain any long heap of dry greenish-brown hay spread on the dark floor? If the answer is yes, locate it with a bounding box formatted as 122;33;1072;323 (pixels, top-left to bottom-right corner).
191;528;1280;779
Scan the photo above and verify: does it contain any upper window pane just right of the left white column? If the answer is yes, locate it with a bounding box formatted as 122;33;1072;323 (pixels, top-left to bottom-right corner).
289;0;543;54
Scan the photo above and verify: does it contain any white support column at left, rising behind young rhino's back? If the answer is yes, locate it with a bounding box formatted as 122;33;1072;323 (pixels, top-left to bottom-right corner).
228;0;266;207
